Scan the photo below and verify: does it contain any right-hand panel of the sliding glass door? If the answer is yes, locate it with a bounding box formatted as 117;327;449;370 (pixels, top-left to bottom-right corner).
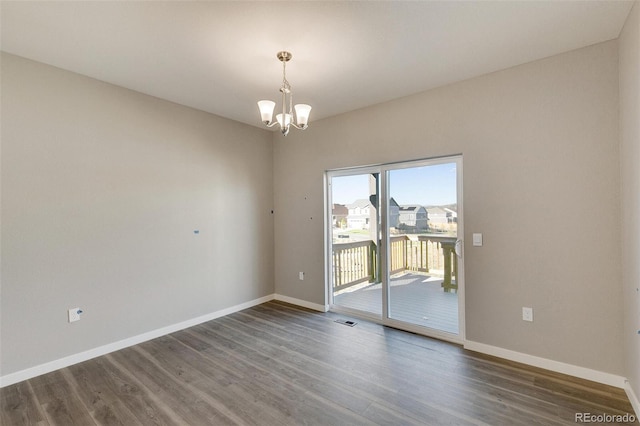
386;160;459;334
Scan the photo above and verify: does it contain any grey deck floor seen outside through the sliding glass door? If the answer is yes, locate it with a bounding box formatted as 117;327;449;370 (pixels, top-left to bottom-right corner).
334;273;459;334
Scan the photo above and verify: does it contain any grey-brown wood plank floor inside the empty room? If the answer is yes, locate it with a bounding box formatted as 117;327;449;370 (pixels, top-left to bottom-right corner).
0;302;637;426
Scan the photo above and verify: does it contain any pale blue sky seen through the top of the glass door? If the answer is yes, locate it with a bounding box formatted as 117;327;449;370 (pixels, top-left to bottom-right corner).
331;163;456;206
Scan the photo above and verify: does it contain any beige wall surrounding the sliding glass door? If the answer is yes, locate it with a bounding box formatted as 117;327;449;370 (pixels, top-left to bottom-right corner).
274;41;623;374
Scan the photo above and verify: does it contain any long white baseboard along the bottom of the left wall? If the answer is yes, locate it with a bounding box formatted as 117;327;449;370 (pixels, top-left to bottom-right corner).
0;294;274;388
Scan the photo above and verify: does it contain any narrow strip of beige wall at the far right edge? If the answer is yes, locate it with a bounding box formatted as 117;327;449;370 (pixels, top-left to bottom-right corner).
620;1;640;395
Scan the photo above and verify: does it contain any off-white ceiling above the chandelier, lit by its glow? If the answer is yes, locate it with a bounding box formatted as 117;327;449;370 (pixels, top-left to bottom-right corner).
0;0;633;126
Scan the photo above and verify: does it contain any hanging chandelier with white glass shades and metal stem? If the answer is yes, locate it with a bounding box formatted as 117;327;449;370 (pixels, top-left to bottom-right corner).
258;51;311;136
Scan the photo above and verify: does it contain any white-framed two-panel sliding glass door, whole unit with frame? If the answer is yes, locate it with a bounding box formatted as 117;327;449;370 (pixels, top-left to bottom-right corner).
327;156;464;341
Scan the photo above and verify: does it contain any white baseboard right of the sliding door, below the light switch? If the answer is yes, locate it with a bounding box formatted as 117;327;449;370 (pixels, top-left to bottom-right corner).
464;340;626;388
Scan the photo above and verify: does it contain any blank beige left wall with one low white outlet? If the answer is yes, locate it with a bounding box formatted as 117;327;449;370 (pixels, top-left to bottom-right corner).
0;54;274;375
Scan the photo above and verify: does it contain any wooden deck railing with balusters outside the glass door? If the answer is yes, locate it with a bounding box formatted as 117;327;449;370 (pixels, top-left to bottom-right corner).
332;235;458;292
